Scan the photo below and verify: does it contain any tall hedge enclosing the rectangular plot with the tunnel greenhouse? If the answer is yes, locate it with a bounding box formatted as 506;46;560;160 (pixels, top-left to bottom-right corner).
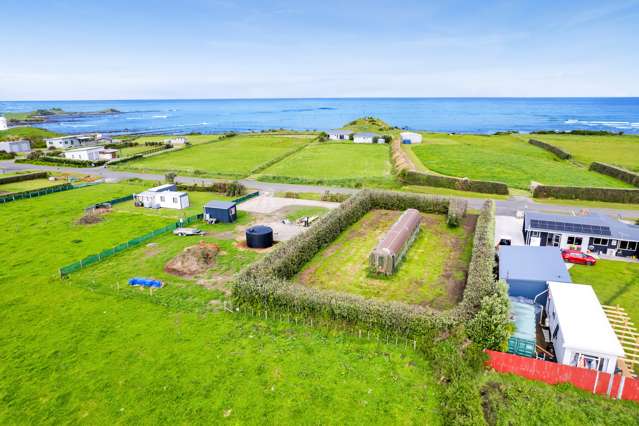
233;190;508;344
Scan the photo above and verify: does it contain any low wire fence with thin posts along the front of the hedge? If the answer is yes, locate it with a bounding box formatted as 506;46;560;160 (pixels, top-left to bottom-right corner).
223;301;421;351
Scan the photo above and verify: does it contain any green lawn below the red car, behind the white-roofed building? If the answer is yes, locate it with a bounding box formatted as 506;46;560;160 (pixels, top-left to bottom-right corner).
570;260;639;327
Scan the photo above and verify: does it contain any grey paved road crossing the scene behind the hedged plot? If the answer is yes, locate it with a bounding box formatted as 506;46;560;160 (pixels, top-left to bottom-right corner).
0;161;639;218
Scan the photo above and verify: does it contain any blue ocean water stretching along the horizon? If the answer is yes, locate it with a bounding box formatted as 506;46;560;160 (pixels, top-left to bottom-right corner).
0;98;639;134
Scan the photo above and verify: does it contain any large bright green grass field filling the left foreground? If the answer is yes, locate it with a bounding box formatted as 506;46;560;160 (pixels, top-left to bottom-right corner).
0;184;442;424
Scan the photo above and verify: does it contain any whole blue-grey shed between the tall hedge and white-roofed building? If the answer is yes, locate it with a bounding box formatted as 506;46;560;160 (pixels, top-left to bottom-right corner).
499;246;572;305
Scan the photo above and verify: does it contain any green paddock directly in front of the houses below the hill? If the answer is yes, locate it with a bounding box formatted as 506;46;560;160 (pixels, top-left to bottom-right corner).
262;143;391;180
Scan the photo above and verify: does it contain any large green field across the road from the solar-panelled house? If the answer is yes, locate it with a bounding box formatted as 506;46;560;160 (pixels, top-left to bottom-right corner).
411;134;630;189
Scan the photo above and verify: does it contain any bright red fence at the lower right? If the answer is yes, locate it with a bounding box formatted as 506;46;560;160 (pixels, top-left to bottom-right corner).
486;350;639;402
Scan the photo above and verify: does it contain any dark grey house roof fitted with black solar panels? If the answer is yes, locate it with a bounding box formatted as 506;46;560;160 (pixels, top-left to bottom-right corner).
524;212;639;241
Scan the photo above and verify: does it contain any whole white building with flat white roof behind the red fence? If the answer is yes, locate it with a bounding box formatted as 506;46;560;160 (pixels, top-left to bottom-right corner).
546;282;625;374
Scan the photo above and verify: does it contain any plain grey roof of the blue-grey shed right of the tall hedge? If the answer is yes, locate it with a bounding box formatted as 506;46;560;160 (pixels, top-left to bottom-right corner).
499;246;572;283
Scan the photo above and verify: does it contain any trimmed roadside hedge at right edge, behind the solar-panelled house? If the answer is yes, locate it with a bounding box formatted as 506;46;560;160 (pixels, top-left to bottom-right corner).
533;185;639;204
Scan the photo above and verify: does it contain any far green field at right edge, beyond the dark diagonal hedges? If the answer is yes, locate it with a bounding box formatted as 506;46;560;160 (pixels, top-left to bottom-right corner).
526;135;639;171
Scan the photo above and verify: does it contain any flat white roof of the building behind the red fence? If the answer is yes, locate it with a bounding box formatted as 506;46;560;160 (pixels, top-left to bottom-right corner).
548;282;625;357
